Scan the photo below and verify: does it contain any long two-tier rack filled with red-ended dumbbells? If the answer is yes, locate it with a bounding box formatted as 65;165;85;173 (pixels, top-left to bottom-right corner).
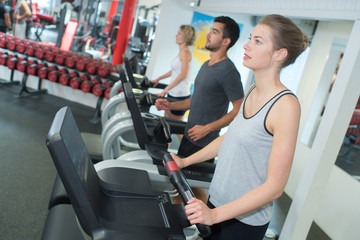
0;32;118;122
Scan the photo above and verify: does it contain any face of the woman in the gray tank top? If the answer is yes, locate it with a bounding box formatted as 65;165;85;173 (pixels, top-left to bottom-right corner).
243;24;275;70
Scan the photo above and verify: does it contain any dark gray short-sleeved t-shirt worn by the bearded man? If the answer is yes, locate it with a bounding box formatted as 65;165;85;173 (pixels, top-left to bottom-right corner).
185;58;244;147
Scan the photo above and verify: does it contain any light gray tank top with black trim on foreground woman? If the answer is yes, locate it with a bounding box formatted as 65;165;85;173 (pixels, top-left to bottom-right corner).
209;85;293;226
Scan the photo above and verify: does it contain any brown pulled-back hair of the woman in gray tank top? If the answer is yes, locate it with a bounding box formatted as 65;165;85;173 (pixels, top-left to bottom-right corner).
259;14;308;68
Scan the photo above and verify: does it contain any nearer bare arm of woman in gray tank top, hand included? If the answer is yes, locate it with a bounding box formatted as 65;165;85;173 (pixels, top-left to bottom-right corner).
185;95;300;225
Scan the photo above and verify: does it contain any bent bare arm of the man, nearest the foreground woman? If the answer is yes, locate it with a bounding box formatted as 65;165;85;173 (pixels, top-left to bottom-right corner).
188;98;244;141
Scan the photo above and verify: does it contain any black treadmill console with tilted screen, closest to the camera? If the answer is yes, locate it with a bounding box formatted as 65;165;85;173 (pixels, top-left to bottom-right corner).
46;107;189;240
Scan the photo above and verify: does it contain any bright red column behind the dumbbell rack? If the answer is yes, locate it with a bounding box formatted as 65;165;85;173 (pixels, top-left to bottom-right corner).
112;0;136;65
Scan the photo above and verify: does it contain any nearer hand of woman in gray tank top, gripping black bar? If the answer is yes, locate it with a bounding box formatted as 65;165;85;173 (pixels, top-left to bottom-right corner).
185;198;216;226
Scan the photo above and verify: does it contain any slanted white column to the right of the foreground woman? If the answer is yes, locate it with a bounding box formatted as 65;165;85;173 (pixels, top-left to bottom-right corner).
279;20;360;240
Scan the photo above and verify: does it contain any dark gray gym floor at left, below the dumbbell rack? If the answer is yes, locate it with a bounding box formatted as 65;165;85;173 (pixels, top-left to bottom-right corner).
0;85;101;240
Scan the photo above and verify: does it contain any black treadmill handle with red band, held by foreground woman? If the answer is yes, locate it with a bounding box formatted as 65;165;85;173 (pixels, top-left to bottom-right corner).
163;152;211;237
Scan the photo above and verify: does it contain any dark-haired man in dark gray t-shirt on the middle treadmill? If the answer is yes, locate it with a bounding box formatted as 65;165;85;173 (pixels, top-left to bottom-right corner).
155;16;244;203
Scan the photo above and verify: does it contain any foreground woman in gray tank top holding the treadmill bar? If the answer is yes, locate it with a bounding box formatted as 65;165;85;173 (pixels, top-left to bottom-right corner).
173;15;308;240
